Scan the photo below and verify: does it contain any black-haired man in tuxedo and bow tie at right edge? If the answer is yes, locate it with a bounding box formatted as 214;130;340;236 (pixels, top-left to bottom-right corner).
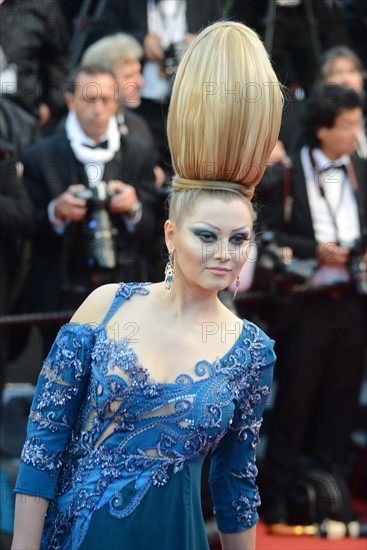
262;85;367;524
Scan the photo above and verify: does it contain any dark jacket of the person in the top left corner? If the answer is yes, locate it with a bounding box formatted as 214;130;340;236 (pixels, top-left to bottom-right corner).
0;0;69;117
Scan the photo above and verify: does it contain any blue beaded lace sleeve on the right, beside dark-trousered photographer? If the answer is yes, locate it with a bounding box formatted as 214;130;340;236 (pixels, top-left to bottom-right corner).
209;329;275;533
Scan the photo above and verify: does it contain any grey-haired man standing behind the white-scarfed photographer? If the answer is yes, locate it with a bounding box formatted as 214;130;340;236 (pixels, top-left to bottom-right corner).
81;33;166;187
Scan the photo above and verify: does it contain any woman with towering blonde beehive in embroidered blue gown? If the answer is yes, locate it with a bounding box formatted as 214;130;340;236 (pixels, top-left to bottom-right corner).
13;22;282;550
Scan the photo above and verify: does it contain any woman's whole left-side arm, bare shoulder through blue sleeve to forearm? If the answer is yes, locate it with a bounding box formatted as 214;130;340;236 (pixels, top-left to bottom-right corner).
12;285;118;550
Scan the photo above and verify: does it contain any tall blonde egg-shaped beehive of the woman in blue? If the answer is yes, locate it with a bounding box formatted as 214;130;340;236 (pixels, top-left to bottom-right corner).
167;22;283;203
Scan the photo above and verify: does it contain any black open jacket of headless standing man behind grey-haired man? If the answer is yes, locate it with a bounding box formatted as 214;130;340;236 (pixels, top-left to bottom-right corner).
86;0;223;47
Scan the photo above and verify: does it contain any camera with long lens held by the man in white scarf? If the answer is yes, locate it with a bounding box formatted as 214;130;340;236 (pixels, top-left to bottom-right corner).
74;181;118;269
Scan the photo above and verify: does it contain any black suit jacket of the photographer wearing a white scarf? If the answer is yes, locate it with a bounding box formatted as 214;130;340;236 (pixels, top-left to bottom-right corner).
23;132;156;311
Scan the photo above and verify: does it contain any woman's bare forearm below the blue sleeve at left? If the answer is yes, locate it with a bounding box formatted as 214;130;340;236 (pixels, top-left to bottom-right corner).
11;493;49;550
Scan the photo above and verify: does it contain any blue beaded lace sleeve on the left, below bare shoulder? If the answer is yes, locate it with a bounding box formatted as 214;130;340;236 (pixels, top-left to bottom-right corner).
15;323;93;499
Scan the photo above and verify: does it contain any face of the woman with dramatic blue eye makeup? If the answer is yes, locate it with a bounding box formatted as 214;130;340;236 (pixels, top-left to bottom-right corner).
165;197;253;291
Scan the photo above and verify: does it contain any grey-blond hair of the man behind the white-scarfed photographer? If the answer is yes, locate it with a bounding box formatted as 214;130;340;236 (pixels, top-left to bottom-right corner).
81;32;144;70
